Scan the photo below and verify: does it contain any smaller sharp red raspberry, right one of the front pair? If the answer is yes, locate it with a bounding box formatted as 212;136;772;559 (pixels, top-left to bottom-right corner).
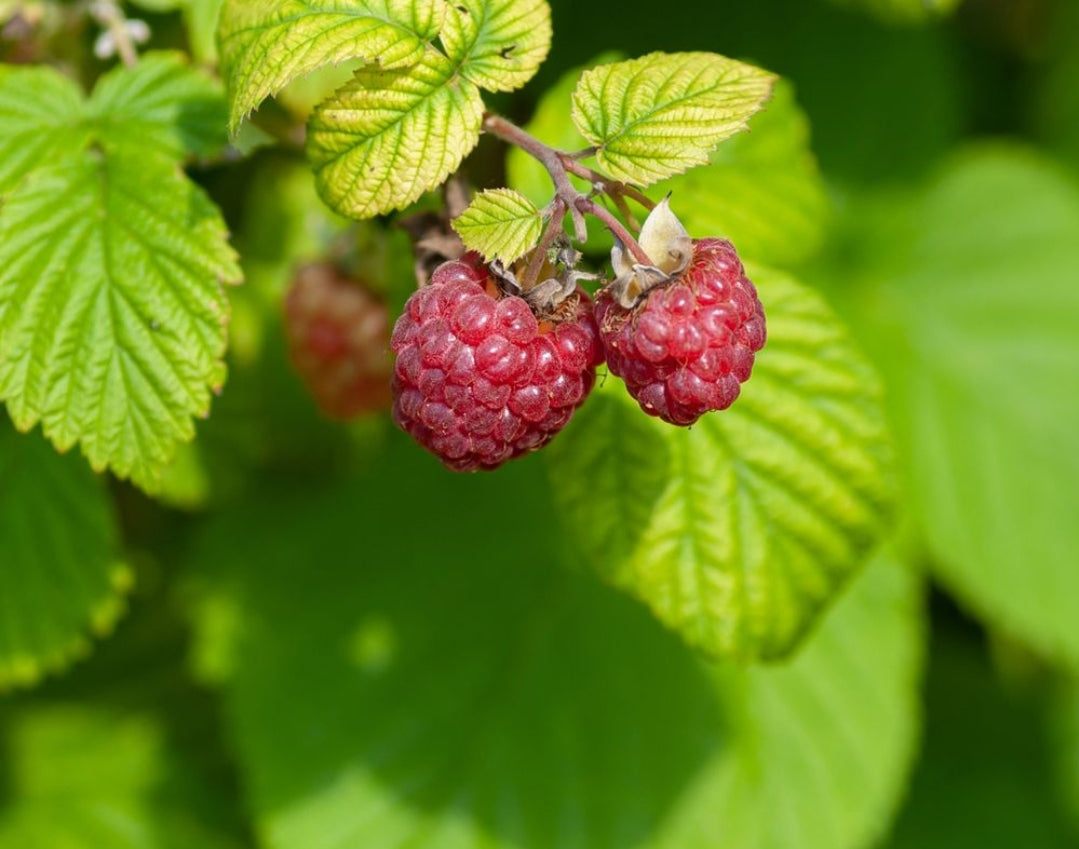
596;238;765;425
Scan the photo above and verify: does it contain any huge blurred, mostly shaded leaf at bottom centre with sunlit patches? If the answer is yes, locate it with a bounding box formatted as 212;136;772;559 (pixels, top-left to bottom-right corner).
195;455;920;849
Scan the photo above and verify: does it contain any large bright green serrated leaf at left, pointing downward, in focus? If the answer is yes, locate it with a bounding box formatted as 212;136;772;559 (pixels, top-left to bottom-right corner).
0;151;240;491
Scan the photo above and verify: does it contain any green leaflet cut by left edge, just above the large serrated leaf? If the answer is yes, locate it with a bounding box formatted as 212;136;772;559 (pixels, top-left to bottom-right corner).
0;65;90;193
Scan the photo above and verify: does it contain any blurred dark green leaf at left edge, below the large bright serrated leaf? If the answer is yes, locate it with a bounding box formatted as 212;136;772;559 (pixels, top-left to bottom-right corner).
0;422;132;690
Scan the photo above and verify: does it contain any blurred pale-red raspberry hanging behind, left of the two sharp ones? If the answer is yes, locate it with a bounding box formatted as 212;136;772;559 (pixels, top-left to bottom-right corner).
285;262;391;420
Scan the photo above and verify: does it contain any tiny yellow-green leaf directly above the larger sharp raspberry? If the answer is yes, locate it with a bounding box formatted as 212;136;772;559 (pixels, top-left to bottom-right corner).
453;189;543;263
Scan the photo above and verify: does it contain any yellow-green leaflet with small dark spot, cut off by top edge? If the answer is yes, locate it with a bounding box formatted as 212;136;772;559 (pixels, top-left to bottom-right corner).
438;0;551;92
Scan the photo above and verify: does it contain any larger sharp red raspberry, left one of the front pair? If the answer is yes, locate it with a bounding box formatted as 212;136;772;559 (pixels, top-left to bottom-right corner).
392;255;602;471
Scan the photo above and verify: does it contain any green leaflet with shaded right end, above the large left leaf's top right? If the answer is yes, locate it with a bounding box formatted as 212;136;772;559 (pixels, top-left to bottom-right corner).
86;53;228;159
